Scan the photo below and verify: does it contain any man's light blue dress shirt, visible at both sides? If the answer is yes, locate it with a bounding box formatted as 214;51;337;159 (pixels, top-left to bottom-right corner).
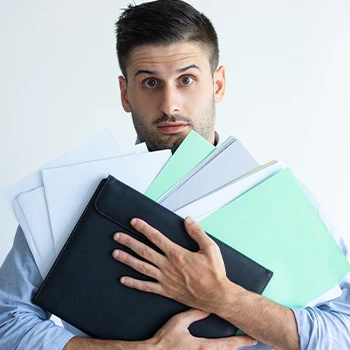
0;182;350;350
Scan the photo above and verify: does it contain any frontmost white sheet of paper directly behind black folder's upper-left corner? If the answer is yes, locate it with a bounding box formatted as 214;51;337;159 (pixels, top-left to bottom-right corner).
42;150;171;252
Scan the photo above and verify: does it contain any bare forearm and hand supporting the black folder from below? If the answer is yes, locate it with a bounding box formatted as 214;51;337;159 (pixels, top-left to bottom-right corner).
64;309;256;350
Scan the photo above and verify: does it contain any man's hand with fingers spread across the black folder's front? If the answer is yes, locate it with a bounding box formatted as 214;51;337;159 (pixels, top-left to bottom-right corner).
113;217;235;312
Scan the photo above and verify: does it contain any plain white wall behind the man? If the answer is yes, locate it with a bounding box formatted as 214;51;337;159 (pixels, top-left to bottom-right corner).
0;0;350;264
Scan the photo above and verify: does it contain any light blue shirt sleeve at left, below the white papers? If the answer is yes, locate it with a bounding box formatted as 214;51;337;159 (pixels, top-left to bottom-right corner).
0;227;74;350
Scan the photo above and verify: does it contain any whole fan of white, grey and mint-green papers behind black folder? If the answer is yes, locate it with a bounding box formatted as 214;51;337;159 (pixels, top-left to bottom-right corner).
5;130;350;307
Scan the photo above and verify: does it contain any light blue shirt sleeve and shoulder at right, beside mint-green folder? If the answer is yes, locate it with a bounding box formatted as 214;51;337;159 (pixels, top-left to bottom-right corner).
292;184;350;350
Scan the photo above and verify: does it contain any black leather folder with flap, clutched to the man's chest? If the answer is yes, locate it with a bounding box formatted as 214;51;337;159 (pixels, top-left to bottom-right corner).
34;176;272;341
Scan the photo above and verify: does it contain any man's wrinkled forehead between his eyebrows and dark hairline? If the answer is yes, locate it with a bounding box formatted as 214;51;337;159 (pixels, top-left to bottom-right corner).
128;43;210;76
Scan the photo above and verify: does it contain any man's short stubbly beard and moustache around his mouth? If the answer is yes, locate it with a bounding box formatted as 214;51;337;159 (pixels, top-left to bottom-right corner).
130;98;216;153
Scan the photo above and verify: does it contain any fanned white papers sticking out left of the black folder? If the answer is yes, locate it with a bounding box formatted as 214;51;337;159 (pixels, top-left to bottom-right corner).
5;129;171;278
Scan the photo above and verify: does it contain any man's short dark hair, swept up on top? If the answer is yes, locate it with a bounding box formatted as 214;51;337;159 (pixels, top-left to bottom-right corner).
115;0;219;78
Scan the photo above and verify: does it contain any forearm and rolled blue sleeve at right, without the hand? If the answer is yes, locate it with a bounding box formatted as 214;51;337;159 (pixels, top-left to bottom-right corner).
211;274;350;350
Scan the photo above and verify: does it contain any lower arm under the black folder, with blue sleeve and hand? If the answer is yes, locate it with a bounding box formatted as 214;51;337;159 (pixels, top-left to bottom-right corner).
0;227;255;350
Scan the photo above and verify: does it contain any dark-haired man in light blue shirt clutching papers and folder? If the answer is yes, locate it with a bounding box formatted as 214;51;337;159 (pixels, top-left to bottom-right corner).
0;0;350;350
